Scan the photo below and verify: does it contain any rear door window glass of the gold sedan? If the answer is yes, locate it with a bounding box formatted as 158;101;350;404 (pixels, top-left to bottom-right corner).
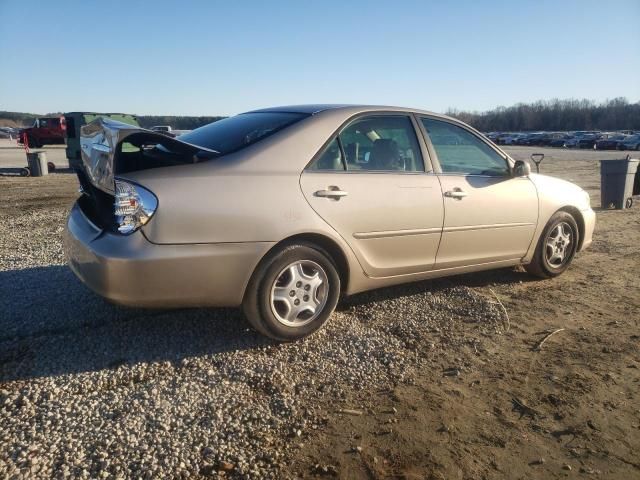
338;115;424;172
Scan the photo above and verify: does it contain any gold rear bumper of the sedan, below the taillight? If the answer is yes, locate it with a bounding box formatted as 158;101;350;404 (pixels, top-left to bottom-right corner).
64;204;273;307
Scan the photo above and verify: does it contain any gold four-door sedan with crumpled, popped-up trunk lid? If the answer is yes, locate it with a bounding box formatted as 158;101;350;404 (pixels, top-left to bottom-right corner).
65;105;595;341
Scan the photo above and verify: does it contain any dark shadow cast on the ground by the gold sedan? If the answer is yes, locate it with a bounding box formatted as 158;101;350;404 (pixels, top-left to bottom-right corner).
0;265;532;383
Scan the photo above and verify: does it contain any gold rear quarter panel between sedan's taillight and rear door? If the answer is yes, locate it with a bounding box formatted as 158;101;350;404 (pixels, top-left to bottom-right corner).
120;107;368;244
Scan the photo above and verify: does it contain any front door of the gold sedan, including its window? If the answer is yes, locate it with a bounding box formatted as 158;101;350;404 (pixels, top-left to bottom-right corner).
420;116;538;269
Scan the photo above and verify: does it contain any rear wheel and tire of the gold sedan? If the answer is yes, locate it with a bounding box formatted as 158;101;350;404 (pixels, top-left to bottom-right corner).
242;242;340;342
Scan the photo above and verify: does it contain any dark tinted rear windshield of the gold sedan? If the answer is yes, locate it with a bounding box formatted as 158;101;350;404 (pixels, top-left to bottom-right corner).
179;112;308;155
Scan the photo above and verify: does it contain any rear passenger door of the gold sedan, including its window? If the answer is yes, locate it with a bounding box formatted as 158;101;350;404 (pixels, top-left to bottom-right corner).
300;114;443;277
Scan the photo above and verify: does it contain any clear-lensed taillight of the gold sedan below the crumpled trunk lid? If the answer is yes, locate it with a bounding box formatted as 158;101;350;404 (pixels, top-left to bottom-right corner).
113;179;158;235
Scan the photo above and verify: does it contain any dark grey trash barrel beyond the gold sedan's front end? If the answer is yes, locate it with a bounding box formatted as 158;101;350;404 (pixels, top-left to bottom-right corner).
600;158;640;208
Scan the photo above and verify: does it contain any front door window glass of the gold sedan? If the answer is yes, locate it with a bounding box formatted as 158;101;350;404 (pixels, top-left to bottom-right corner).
420;118;510;177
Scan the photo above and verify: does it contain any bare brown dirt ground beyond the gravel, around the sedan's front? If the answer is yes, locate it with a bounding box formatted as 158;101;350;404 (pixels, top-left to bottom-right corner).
0;148;640;479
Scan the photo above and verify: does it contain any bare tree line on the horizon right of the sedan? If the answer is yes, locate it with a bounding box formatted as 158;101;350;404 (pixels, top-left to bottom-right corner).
447;97;640;132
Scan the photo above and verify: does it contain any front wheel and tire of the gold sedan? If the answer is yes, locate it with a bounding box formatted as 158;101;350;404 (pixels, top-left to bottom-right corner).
524;212;580;278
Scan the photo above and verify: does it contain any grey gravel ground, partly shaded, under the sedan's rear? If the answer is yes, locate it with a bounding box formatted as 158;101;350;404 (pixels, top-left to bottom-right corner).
0;201;505;478
